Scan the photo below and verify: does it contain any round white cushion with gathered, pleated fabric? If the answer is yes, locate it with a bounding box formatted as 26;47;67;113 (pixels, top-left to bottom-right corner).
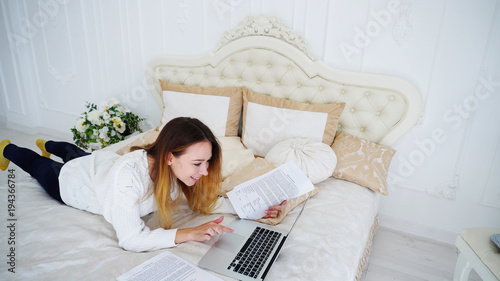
266;138;337;184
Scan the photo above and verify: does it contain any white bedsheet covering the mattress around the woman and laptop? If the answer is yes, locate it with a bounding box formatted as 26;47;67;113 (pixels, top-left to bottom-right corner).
0;164;379;280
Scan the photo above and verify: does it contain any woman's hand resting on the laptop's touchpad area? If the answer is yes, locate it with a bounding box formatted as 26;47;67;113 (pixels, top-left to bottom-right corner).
175;216;234;244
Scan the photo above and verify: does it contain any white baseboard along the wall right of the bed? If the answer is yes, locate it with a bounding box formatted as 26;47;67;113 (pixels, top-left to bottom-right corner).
378;214;459;245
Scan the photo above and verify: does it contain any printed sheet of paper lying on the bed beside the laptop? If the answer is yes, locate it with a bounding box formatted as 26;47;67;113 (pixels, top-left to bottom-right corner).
117;251;222;281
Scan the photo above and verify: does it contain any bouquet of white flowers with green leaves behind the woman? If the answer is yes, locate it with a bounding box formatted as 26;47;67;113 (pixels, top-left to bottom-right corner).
71;99;144;150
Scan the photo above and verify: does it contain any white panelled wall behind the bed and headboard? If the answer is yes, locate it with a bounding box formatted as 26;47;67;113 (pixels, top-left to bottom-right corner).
0;0;500;243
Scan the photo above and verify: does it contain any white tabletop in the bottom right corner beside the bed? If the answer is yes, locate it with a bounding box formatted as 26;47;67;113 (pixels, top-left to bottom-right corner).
461;227;500;277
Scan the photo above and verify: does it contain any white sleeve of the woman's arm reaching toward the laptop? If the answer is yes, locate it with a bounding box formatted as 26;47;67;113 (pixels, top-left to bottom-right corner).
104;162;177;252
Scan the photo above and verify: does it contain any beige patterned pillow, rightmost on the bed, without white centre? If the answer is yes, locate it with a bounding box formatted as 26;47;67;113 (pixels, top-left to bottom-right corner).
332;132;396;195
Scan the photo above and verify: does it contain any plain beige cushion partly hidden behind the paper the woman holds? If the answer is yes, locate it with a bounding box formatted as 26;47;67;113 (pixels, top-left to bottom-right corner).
221;158;319;225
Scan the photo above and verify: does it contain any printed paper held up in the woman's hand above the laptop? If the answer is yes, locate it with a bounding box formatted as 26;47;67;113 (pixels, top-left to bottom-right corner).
227;162;314;220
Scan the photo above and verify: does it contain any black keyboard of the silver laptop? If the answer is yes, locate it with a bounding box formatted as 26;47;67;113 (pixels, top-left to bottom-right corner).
227;227;281;278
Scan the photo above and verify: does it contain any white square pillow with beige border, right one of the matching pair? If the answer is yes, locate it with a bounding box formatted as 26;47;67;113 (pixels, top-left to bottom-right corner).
242;88;345;157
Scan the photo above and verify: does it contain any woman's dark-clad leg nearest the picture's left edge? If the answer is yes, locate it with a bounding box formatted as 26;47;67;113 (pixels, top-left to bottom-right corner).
3;144;63;203
